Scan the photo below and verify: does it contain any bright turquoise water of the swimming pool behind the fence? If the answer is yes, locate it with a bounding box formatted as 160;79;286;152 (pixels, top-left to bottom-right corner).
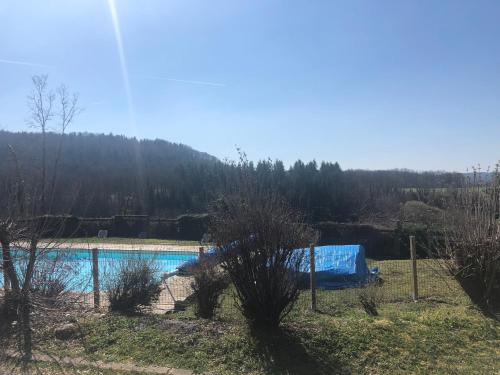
0;249;198;292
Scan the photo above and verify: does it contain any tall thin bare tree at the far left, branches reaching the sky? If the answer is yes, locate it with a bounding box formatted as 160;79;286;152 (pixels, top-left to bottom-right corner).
0;76;80;361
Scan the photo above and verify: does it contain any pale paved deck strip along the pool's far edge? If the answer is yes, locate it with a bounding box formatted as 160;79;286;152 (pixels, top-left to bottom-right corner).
36;242;200;253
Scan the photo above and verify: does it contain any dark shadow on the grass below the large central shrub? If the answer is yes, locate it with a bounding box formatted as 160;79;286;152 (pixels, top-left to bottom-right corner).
251;328;351;375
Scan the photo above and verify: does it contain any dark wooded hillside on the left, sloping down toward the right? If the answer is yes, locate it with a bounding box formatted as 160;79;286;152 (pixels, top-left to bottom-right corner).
0;131;221;216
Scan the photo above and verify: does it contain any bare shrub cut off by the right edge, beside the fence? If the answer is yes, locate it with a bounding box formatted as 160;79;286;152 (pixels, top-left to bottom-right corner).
438;165;500;307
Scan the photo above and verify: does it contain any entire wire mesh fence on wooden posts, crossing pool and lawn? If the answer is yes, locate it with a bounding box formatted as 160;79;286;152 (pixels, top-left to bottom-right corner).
0;245;463;313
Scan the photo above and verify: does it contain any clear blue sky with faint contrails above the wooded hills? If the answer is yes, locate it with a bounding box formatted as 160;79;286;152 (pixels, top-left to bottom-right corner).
0;0;500;171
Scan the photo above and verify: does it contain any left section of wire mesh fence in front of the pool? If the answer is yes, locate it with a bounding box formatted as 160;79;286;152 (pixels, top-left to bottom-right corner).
0;248;199;313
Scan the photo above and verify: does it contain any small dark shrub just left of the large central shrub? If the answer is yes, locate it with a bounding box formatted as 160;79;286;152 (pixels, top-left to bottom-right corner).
189;256;229;319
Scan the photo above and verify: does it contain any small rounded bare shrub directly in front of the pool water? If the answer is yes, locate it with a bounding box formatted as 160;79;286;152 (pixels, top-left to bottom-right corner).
107;259;161;313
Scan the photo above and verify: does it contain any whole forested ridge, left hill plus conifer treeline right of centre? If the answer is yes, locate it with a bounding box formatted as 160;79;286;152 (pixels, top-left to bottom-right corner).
0;131;463;221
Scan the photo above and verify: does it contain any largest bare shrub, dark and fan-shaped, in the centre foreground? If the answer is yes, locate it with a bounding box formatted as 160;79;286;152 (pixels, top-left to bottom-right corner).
209;187;316;327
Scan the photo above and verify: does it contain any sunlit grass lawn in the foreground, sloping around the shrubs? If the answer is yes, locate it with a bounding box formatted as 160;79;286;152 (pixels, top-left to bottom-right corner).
33;261;500;375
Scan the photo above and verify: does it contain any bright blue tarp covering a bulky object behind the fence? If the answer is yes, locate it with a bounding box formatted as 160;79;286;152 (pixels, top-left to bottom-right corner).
302;245;375;289
